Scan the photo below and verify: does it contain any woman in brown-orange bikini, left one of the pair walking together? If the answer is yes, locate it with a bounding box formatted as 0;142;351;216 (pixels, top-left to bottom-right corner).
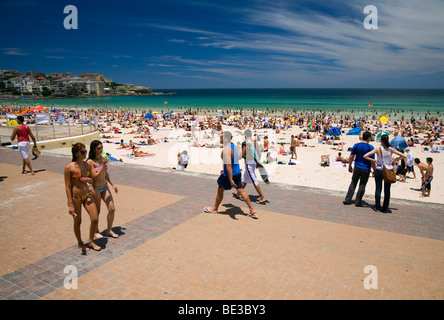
64;142;101;252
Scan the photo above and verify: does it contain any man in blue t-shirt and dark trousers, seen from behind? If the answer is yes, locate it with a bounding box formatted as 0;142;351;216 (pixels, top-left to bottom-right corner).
343;131;374;207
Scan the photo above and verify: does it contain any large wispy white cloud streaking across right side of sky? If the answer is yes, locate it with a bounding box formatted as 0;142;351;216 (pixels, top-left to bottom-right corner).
143;0;444;85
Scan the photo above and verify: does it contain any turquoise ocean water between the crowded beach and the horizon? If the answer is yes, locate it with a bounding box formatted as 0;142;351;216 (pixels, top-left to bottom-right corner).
0;89;444;114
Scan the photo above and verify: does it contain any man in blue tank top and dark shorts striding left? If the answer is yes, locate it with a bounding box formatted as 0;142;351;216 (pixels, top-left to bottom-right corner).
204;131;258;219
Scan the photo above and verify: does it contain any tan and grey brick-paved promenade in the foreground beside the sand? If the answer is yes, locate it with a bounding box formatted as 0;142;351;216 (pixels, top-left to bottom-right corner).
0;148;444;300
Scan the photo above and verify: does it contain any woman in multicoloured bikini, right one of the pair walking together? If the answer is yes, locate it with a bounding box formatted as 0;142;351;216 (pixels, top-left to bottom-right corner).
87;140;119;238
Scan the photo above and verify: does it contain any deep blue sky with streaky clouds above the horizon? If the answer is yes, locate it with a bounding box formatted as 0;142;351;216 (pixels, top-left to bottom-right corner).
0;0;444;89
